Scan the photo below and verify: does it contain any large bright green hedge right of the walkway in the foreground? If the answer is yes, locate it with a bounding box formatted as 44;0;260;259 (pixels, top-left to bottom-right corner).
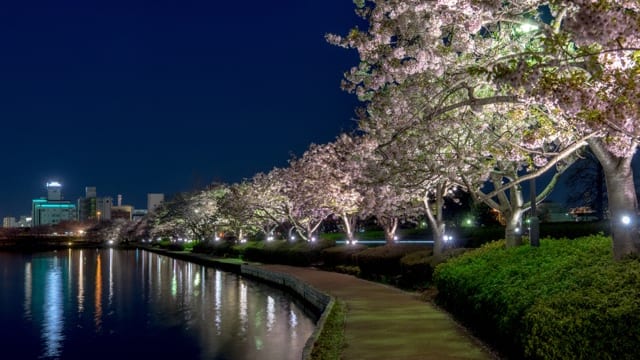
434;235;640;359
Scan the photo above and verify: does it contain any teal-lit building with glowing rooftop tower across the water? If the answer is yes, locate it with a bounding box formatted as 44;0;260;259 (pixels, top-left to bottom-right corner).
31;181;77;226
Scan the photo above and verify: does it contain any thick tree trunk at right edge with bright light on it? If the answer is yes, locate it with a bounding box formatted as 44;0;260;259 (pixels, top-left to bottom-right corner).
589;139;640;260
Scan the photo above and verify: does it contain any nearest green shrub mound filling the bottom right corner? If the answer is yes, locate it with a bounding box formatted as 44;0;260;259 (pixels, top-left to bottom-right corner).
523;260;640;359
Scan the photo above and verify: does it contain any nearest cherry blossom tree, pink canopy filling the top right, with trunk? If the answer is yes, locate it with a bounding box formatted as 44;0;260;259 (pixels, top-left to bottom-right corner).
336;0;640;258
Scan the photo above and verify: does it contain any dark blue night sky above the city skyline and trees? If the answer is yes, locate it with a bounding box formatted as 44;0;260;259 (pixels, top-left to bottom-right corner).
0;0;358;217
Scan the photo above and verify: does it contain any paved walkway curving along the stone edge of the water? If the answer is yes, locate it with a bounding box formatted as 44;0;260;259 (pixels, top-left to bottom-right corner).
261;265;495;360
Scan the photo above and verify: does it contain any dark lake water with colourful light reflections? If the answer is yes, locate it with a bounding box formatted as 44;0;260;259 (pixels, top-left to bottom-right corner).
0;249;315;360
